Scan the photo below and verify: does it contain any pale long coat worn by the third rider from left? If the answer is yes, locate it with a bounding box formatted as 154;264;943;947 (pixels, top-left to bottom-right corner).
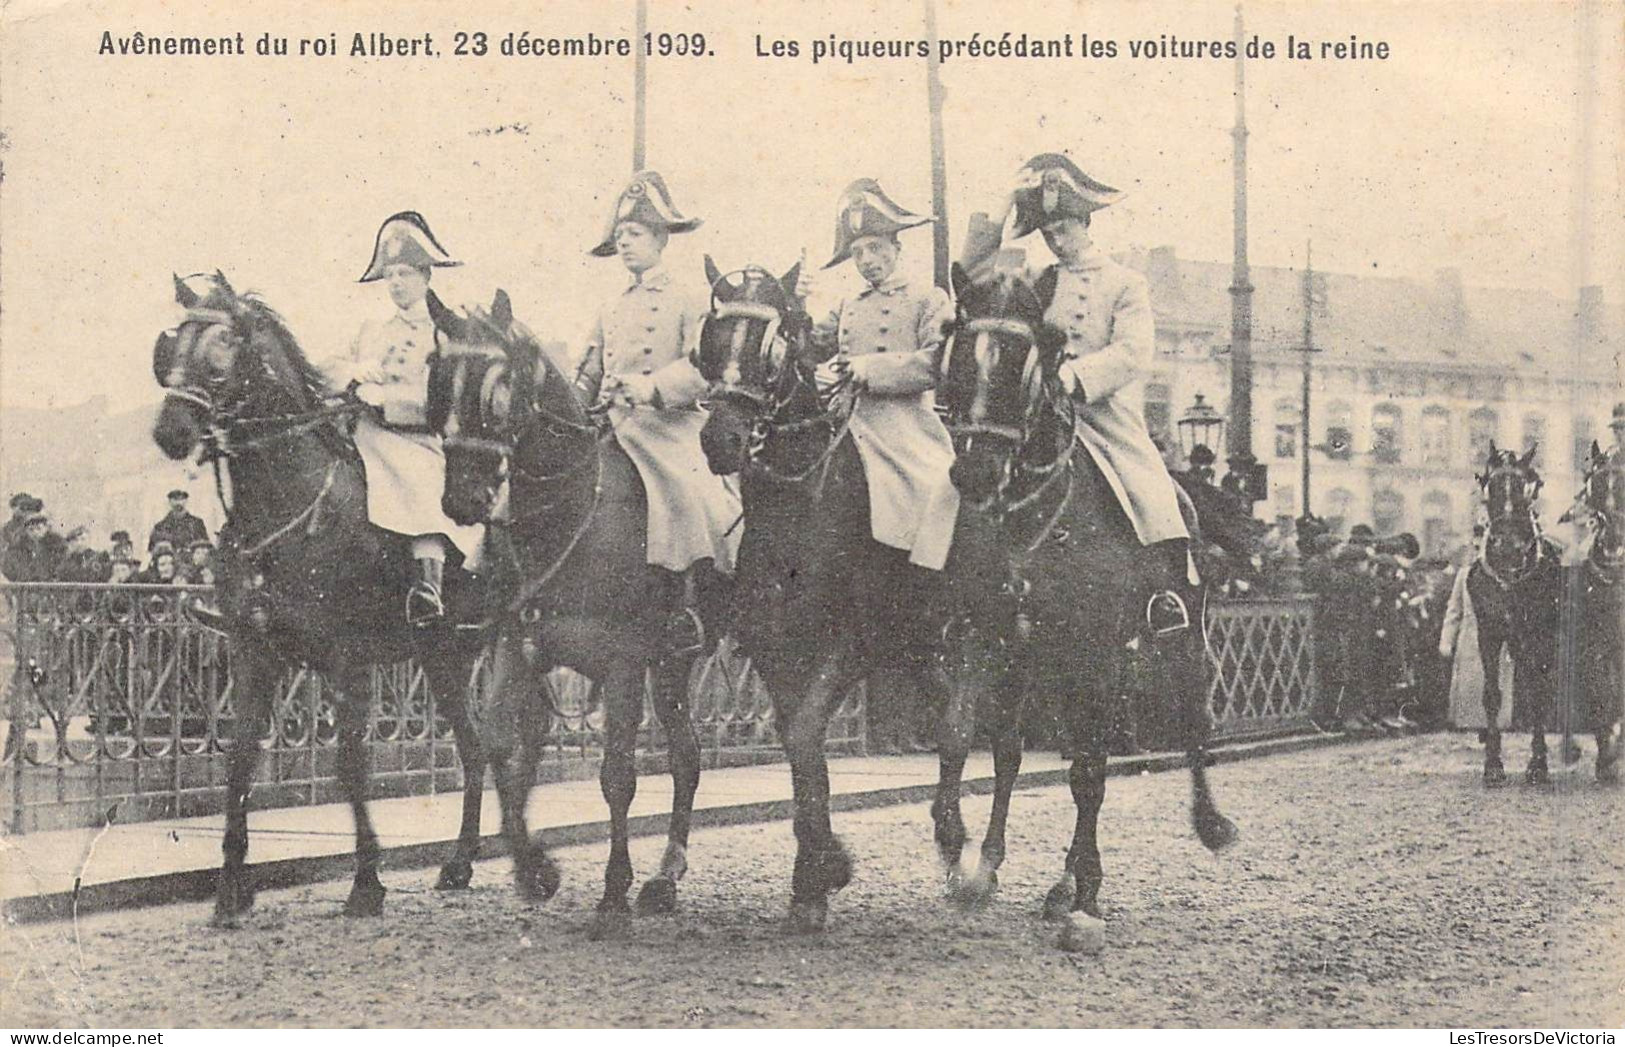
819;276;959;571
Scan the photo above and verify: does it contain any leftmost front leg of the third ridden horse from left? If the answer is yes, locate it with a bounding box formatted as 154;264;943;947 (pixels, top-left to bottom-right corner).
782;652;852;933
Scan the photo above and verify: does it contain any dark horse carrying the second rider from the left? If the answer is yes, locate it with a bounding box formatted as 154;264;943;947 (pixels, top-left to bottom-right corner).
429;291;700;936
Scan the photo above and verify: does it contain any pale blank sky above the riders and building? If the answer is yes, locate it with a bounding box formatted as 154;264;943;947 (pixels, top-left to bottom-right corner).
0;0;1625;416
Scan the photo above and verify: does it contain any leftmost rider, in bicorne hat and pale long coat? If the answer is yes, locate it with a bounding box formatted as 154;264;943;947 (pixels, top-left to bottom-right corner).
323;211;486;626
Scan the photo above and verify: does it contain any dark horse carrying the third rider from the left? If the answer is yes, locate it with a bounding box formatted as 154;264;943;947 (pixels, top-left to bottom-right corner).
697;258;1021;932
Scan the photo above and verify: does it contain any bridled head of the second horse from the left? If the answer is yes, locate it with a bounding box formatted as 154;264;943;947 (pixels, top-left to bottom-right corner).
426;291;592;525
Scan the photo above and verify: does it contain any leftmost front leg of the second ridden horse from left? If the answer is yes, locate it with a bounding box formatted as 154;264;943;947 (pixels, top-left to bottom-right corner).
479;634;561;902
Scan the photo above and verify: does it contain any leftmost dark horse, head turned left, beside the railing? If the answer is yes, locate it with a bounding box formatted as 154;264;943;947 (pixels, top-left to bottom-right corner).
153;273;484;925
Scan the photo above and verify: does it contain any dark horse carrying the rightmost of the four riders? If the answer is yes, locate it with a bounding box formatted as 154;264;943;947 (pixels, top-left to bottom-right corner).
938;267;1237;942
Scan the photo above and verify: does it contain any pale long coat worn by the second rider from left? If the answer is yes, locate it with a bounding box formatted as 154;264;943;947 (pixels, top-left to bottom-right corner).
579;265;741;572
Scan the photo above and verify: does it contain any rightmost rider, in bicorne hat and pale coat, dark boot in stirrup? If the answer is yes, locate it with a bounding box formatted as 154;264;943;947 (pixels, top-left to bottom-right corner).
964;153;1194;629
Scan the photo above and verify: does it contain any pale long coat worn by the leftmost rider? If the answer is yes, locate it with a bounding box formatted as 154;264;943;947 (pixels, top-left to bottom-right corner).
323;302;486;567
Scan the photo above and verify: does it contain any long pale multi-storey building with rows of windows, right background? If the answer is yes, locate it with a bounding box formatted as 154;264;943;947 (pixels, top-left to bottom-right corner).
1123;247;1622;556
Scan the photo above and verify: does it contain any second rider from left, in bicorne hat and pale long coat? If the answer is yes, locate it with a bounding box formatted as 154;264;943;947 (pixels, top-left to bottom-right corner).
575;171;741;644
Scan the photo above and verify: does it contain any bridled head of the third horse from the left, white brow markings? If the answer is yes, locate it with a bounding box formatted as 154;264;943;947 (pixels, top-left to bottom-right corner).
694;255;817;476
